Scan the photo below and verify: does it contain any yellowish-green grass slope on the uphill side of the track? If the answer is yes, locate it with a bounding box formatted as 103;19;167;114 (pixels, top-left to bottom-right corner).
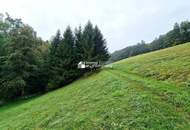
116;43;190;86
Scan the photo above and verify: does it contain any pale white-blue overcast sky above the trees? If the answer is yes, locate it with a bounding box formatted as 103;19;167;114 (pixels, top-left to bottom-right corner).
0;0;190;52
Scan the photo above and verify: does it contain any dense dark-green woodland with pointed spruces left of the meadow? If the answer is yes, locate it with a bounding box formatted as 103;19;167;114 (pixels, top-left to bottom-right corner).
0;14;109;102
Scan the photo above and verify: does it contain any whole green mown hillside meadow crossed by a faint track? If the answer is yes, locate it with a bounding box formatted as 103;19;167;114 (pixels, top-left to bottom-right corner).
0;43;190;130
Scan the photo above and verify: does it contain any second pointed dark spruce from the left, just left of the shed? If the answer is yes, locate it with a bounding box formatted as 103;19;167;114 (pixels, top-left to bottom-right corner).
49;26;77;89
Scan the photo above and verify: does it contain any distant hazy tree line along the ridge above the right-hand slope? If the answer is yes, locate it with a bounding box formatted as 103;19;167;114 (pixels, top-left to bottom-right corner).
108;21;190;63
